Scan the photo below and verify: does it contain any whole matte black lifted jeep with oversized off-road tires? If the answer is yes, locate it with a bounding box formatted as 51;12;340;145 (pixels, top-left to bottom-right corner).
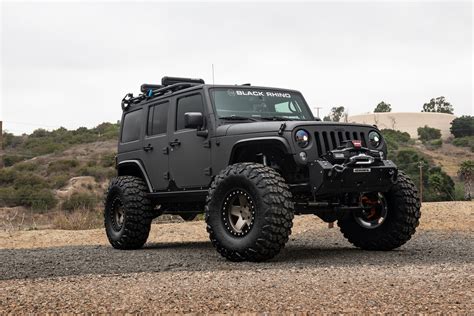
104;77;420;261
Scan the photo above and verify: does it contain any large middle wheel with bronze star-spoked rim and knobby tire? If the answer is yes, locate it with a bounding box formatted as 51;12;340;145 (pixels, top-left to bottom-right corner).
206;163;293;261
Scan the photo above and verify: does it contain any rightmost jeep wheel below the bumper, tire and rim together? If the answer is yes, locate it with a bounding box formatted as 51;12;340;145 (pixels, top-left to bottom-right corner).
338;172;421;250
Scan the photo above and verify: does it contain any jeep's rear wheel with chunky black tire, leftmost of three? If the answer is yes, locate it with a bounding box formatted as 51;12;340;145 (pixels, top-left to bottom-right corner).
104;176;153;249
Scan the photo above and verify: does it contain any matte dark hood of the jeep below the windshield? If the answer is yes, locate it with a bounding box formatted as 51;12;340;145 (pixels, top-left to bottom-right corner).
216;121;373;136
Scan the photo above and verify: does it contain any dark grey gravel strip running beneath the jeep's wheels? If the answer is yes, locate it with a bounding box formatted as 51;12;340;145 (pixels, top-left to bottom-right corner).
0;232;473;280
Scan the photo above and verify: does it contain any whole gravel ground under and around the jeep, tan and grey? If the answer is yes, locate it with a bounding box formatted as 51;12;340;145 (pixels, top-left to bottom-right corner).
0;202;474;314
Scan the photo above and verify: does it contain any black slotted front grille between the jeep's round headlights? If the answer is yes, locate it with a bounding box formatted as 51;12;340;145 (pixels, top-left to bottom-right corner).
314;130;367;157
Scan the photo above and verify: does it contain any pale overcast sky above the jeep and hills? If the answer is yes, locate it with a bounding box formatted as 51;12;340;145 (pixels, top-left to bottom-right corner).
0;0;474;134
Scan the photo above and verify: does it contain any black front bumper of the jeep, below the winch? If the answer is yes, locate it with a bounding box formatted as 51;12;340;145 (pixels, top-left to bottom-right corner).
309;160;398;196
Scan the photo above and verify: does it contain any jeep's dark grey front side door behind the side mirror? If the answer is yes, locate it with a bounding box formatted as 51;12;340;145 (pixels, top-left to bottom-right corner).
169;92;211;188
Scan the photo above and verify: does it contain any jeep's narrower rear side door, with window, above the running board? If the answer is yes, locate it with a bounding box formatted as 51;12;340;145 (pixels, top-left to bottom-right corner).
143;100;170;191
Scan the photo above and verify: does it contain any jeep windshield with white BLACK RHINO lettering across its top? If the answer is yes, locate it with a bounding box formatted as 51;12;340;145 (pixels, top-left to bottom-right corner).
211;87;313;121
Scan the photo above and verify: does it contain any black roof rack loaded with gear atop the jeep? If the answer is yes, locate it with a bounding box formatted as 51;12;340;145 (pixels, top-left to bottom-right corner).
121;76;205;111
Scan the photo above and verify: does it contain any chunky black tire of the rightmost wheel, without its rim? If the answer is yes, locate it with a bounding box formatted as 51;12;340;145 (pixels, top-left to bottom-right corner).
338;172;421;250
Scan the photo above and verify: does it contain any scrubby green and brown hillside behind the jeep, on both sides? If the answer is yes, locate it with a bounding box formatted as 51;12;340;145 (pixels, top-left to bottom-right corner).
0;123;474;229
